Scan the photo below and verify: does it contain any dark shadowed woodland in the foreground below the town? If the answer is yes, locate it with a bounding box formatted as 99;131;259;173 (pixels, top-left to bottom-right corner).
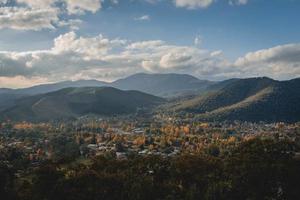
0;138;300;200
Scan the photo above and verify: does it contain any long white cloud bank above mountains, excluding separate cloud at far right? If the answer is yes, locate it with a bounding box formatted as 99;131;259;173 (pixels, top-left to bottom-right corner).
0;32;227;86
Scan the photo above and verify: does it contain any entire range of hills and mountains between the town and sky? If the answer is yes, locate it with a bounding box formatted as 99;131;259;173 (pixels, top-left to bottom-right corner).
0;74;300;122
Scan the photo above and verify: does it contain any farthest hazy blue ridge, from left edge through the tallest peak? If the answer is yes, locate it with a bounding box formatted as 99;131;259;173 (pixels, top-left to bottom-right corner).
0;74;213;111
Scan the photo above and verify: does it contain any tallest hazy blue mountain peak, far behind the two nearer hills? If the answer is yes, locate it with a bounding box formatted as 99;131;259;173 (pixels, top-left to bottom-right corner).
111;73;213;97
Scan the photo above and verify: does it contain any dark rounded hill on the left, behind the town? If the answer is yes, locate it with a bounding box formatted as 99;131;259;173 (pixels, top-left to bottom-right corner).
0;87;164;120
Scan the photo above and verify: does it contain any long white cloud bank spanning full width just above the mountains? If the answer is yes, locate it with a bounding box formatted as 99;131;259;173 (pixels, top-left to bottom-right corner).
0;32;300;87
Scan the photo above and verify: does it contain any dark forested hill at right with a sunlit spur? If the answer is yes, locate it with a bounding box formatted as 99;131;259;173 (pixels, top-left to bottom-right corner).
174;78;300;122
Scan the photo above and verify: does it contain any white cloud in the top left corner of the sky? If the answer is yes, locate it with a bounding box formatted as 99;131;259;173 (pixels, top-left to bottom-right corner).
0;0;104;31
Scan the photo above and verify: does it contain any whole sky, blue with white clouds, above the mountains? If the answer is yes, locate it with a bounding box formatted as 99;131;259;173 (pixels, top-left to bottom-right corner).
0;0;300;88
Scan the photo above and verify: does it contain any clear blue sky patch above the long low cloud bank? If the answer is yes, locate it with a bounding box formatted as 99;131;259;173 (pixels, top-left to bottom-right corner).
94;0;300;58
